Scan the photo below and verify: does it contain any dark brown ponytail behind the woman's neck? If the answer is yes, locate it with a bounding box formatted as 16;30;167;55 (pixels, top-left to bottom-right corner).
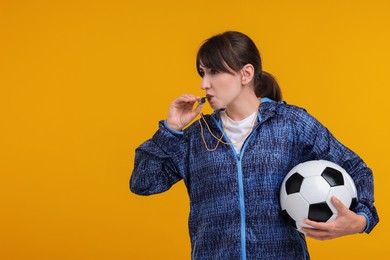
255;71;282;101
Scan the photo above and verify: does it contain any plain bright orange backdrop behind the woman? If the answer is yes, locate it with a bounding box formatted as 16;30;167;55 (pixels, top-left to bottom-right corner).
0;0;390;260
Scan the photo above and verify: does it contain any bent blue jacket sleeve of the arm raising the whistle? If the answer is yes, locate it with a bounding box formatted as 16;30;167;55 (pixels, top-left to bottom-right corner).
130;121;185;195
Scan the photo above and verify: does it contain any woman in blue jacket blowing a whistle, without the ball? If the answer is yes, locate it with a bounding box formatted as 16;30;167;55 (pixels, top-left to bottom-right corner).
130;31;378;259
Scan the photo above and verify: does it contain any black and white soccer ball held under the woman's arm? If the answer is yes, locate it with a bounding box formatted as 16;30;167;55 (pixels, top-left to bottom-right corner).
280;160;357;231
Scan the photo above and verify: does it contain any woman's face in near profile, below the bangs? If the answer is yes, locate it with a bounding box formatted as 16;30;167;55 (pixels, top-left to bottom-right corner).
199;66;242;109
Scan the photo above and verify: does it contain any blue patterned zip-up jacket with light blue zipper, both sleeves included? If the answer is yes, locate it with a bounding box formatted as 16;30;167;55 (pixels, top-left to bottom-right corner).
130;99;379;260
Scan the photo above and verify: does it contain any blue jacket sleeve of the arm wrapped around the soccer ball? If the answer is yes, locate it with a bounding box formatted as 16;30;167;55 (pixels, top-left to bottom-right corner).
297;107;379;233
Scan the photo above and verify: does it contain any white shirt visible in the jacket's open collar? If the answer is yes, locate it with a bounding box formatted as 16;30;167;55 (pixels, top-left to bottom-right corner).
220;110;258;154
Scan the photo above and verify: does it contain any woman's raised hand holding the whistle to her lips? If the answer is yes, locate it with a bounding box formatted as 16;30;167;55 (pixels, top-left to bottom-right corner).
167;94;204;131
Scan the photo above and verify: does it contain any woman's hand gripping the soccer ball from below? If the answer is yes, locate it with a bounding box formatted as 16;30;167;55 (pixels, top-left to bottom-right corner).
302;197;367;240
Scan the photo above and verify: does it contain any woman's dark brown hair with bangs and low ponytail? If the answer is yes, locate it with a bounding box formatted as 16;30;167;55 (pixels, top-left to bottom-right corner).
196;31;282;101
